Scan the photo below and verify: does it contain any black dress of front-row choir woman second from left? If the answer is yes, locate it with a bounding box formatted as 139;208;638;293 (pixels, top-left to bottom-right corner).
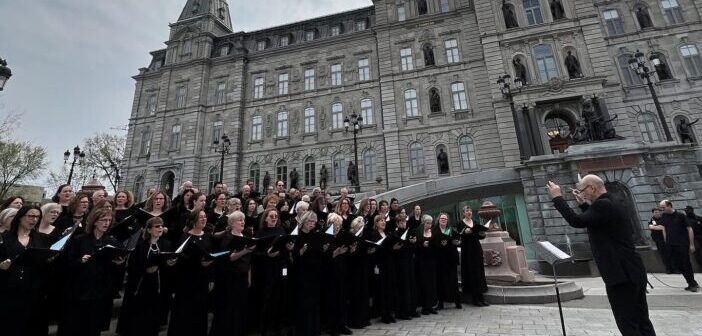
58;233;117;336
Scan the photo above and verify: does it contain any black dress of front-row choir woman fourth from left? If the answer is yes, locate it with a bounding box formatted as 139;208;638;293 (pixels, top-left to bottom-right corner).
168;233;214;336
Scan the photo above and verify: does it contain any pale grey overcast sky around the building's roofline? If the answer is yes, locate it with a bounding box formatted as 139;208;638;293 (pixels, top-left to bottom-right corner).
0;0;372;185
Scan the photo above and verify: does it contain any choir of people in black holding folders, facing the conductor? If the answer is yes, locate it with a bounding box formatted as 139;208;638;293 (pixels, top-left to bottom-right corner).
0;181;487;336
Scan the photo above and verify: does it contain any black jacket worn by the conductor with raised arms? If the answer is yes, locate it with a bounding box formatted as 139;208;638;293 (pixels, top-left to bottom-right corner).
553;193;646;286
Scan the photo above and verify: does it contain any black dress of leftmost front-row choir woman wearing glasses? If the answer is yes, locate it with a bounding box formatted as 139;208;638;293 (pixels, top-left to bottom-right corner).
0;231;49;336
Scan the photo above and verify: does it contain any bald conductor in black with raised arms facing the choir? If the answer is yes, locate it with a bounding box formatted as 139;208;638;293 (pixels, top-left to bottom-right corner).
546;175;656;336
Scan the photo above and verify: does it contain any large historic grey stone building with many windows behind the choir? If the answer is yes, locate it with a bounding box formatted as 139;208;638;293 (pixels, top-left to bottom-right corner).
123;0;702;268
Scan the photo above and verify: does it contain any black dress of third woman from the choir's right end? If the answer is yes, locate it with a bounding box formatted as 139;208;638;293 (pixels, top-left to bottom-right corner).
417;232;438;314
